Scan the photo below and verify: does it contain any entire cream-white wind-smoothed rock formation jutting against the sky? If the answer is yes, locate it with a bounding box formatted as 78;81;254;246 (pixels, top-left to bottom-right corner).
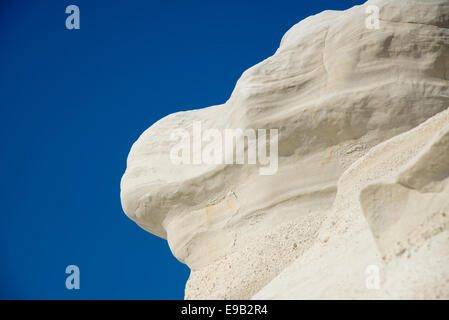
121;0;449;299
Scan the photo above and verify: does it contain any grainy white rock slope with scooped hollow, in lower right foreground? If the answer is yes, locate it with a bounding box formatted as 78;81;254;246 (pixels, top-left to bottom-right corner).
254;109;449;299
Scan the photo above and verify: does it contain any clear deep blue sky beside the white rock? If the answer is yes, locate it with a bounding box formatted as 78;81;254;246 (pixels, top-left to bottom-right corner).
0;0;364;299
